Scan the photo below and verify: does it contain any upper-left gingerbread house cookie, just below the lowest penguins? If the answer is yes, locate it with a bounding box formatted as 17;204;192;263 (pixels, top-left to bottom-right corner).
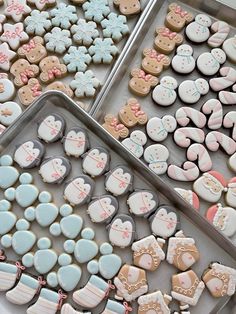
132;235;165;271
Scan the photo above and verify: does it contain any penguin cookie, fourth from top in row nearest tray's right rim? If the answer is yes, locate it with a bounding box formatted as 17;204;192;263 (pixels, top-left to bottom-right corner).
105;166;134;196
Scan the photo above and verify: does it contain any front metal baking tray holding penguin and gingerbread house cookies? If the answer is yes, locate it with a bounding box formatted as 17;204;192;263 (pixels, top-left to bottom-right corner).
0;92;236;314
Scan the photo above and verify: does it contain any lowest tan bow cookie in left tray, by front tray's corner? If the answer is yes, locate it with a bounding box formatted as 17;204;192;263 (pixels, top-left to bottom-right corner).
18;78;42;106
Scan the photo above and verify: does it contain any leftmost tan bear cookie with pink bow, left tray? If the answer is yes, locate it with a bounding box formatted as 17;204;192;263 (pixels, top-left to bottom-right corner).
10;59;39;87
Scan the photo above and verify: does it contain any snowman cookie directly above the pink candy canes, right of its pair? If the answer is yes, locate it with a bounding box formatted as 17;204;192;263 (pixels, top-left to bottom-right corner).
178;78;209;104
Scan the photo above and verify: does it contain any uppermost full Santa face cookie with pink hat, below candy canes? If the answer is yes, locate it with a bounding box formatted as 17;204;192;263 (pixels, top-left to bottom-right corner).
193;171;227;203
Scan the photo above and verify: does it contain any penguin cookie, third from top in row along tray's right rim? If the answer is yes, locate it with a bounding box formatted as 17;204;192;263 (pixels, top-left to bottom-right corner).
82;147;110;177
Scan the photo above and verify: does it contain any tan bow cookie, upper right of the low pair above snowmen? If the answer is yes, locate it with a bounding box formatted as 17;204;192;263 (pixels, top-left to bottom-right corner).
119;98;148;128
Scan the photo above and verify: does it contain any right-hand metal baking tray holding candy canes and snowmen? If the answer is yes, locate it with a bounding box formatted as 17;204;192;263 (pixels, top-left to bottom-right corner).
90;0;236;247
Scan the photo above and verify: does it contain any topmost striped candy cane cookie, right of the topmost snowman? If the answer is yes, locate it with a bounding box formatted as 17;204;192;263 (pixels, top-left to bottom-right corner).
207;21;230;48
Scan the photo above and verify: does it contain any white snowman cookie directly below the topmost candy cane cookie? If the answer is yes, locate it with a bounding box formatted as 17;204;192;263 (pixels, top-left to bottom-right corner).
197;48;226;75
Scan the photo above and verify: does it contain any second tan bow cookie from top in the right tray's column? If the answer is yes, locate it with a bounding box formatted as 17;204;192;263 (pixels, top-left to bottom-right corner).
155;27;184;54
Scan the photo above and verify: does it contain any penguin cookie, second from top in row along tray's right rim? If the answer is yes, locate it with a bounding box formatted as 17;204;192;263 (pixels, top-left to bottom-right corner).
62;127;89;158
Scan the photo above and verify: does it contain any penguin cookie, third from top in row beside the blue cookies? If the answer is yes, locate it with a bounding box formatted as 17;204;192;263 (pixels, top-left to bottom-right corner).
64;175;95;206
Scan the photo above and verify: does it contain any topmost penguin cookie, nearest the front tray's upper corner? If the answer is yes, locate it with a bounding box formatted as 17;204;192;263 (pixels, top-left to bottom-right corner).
38;113;66;143
